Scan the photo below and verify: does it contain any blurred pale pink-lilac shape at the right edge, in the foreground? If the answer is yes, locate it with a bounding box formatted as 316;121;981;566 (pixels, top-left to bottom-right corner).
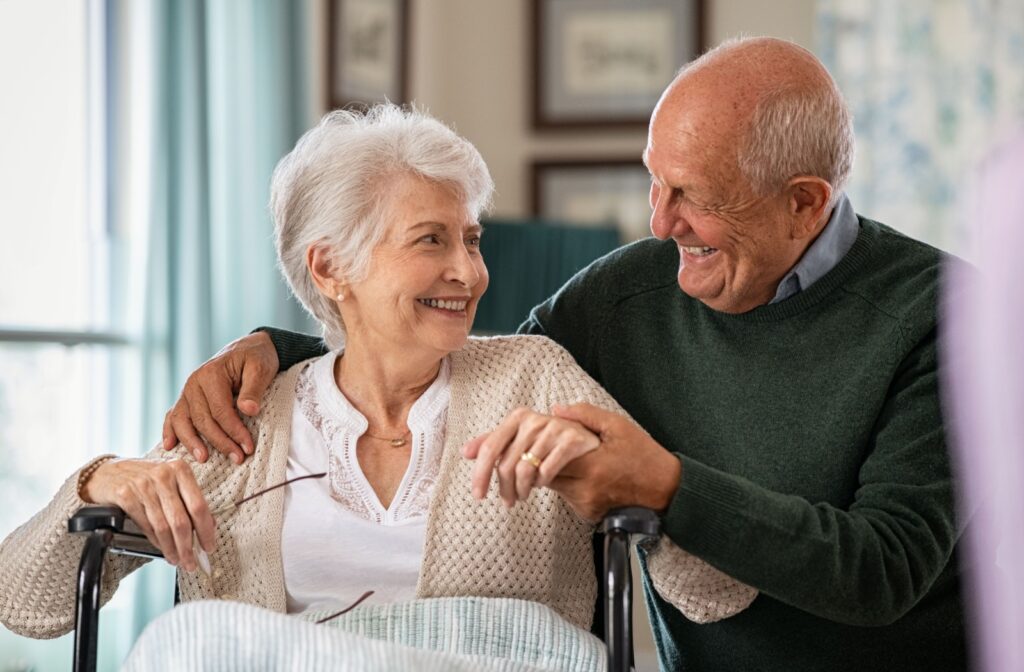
943;133;1024;672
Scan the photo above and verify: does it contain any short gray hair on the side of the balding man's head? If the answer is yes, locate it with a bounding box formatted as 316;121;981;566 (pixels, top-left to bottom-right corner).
683;38;855;207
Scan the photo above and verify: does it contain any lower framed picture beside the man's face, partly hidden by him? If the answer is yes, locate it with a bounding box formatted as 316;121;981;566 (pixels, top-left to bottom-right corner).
530;158;650;242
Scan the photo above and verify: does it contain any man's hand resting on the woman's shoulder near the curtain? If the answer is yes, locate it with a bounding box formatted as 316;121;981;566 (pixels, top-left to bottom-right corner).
163;332;278;464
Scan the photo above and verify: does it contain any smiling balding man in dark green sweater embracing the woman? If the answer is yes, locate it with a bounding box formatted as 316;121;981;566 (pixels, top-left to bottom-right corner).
165;39;966;671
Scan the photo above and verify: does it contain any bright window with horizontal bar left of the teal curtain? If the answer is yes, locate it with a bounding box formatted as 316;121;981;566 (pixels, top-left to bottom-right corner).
0;0;172;670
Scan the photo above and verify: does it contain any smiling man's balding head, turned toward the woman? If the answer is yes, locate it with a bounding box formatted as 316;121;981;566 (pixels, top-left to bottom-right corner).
644;38;853;312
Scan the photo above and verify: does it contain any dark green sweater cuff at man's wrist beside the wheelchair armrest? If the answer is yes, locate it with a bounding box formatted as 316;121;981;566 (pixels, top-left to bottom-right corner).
662;454;746;555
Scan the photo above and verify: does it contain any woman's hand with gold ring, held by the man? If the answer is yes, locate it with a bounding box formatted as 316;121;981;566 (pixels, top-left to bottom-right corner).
462;408;600;506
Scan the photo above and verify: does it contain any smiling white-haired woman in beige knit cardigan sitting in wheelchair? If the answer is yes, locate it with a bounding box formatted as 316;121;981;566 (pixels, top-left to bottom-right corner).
0;106;753;655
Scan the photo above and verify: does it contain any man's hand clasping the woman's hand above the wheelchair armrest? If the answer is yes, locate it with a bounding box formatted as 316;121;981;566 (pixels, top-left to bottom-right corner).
551;404;682;522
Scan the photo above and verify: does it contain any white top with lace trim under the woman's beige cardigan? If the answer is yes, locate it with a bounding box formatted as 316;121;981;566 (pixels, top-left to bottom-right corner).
282;352;451;612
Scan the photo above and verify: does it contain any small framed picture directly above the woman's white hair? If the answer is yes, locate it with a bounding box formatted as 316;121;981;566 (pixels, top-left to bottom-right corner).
327;0;410;108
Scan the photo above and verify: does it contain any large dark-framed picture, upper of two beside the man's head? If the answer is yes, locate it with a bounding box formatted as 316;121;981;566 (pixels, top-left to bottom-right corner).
532;0;703;128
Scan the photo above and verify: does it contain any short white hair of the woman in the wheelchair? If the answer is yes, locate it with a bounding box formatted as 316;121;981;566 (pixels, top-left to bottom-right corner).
270;103;495;349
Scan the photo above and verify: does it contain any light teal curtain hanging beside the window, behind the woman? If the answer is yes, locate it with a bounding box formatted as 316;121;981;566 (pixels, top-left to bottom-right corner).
128;0;315;660
